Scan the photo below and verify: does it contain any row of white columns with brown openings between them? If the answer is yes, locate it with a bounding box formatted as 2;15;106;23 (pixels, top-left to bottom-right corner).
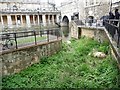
0;14;58;27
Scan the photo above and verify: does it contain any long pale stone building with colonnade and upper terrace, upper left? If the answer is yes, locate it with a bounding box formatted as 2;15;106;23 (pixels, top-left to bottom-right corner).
0;0;60;27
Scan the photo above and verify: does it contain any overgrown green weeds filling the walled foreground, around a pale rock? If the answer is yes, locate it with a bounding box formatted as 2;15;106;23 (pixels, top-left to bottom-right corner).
2;38;120;88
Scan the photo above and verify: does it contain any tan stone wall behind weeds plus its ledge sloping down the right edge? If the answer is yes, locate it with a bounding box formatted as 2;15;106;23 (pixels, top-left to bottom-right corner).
70;23;120;65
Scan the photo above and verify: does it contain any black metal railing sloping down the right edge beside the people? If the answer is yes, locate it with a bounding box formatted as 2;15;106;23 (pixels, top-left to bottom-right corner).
104;19;120;48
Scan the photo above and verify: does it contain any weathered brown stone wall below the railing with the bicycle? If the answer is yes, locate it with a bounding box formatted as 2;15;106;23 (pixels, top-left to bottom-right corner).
0;40;62;75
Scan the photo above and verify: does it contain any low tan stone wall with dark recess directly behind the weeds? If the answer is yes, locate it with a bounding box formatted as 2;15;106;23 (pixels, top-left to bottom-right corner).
70;22;108;42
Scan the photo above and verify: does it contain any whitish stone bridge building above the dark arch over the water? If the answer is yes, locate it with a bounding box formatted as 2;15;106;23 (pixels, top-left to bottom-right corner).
60;0;84;21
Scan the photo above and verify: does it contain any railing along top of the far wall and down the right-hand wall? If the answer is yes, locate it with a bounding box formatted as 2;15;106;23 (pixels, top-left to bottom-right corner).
74;19;120;48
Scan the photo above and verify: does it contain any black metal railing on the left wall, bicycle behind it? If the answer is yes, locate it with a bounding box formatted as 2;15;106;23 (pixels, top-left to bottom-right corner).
0;28;61;51
